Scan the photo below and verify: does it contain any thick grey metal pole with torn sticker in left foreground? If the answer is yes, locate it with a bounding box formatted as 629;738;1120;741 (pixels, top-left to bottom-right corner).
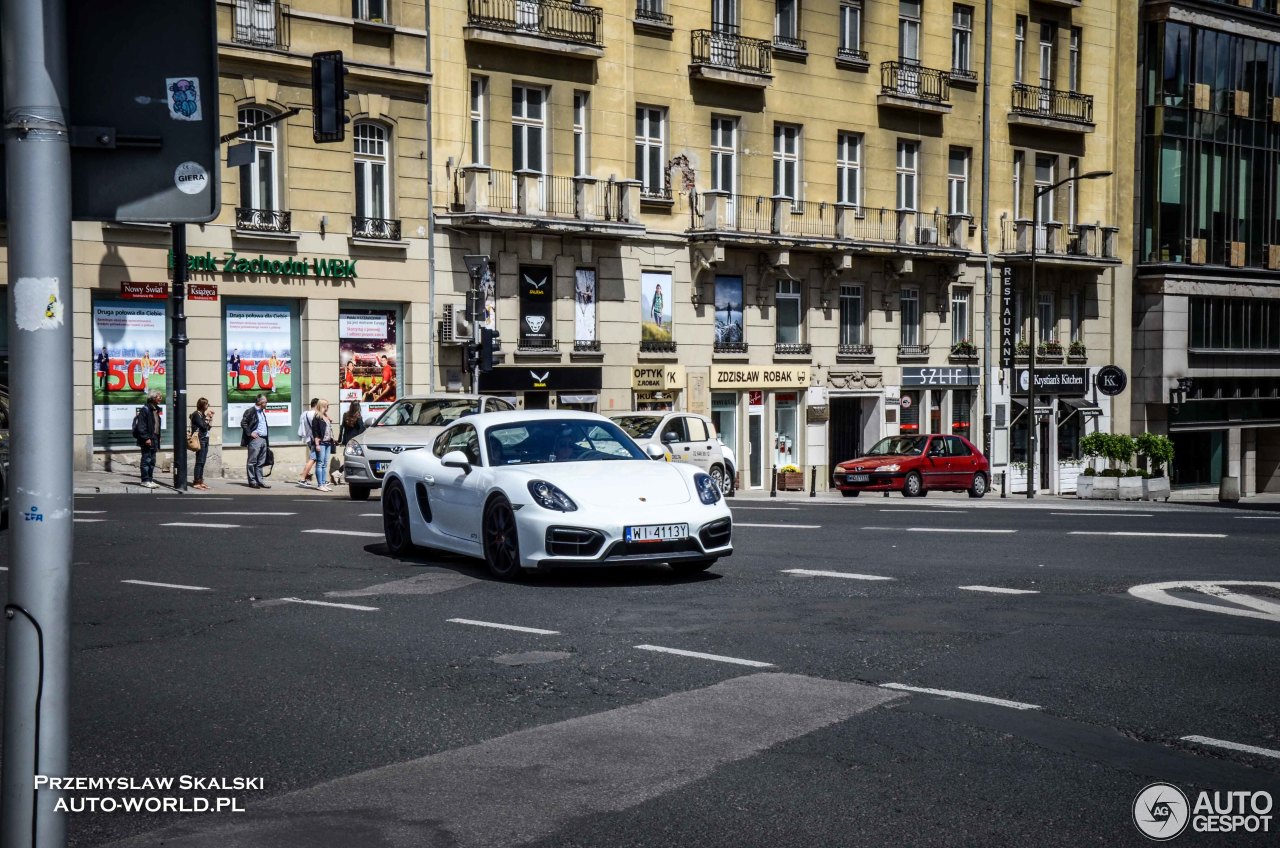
0;0;76;848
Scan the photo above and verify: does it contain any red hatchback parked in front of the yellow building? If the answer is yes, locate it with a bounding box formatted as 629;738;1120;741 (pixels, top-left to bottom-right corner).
833;436;991;497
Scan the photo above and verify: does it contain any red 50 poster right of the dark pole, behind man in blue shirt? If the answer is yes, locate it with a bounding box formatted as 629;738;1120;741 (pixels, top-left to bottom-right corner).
227;305;297;432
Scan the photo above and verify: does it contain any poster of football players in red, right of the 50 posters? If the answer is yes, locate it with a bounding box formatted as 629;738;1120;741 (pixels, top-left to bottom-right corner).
330;310;398;421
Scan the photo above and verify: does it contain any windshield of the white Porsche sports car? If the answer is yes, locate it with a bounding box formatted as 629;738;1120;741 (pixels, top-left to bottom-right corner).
485;419;649;465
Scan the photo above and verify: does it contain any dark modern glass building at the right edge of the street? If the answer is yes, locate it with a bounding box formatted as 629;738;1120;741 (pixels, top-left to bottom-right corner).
1133;0;1280;494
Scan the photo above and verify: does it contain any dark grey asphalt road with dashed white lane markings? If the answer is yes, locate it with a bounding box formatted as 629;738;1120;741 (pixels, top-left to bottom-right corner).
0;489;1280;848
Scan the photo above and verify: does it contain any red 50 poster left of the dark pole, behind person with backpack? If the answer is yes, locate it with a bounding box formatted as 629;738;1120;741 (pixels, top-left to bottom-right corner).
93;300;169;433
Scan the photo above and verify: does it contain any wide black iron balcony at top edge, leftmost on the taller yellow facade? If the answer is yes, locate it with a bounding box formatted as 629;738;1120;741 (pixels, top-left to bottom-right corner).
463;0;604;59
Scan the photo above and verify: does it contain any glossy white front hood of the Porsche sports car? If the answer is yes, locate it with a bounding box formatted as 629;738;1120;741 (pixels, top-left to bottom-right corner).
503;460;694;510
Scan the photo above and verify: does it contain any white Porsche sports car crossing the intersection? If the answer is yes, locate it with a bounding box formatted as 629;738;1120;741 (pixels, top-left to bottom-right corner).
383;410;733;579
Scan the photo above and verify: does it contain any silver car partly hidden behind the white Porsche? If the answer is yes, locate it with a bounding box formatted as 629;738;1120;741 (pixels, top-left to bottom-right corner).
342;395;515;501
